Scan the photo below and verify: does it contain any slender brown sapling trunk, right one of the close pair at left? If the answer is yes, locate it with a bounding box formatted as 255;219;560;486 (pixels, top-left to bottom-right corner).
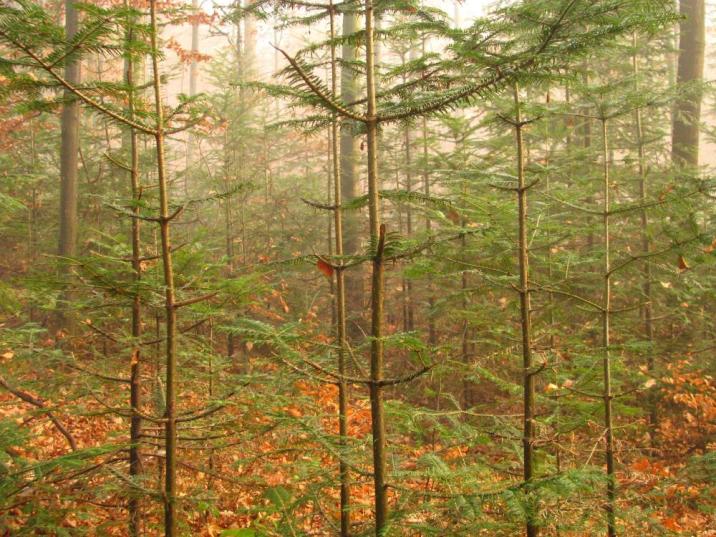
149;0;177;537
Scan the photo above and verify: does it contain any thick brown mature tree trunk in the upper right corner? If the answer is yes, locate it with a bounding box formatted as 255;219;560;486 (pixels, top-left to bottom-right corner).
671;0;706;167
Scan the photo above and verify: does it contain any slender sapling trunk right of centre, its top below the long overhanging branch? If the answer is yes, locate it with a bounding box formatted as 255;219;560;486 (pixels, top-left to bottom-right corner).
514;85;539;537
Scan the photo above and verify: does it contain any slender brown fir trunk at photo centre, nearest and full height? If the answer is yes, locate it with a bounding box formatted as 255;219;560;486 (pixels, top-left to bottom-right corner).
365;0;388;537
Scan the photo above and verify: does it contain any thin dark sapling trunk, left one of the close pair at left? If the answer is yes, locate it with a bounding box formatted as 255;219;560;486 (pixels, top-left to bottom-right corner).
125;7;142;537
